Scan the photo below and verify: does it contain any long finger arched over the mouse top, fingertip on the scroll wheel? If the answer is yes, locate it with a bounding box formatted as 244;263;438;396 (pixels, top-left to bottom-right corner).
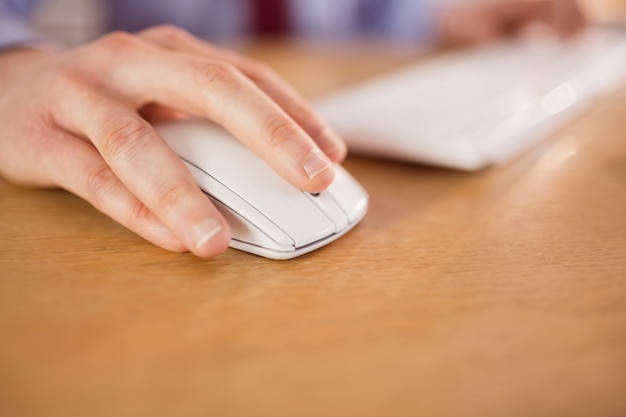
85;34;334;192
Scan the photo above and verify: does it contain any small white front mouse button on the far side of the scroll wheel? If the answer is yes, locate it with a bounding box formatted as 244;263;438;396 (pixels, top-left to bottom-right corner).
326;166;369;223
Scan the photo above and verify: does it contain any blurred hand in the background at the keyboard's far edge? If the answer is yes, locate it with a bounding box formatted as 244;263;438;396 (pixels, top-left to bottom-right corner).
440;0;585;43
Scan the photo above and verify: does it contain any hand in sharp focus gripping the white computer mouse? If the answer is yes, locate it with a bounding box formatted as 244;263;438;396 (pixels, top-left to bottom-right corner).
0;27;346;257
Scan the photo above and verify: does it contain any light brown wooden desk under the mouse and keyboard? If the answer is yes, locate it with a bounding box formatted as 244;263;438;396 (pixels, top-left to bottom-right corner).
0;41;626;417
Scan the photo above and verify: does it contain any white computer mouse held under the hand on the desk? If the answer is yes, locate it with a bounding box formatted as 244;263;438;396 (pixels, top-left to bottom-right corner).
155;120;369;259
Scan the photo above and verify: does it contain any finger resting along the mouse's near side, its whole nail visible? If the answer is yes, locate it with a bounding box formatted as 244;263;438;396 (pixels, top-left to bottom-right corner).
50;82;230;257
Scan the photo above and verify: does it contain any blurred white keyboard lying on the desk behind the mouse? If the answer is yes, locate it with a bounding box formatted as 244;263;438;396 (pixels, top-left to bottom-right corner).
315;28;626;170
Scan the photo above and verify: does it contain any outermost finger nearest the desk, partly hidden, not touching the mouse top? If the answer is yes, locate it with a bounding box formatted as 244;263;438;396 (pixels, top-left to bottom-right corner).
41;128;187;252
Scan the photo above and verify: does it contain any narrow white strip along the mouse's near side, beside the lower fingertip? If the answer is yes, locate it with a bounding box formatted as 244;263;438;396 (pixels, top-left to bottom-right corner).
183;160;295;247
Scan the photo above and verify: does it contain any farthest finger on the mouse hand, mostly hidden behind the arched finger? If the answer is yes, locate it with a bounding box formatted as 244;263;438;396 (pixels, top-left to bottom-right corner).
140;26;347;163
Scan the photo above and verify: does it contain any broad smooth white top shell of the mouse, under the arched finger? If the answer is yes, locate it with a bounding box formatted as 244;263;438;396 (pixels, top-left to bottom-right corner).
159;122;335;247
